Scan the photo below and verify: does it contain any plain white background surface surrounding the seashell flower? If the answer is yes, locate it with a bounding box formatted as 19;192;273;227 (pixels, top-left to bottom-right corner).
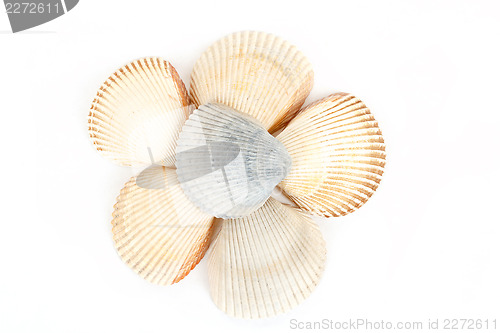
0;0;500;332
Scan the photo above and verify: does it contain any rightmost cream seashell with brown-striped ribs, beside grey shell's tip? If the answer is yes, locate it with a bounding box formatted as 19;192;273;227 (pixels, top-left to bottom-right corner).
277;93;386;217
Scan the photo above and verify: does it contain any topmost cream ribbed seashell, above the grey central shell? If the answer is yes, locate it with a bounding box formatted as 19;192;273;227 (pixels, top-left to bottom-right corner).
190;31;313;133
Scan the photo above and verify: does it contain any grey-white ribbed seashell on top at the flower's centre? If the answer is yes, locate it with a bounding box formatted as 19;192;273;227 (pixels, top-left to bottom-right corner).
175;103;291;218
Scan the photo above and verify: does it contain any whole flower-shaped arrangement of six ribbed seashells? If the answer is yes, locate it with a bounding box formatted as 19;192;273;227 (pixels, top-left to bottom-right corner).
88;32;385;318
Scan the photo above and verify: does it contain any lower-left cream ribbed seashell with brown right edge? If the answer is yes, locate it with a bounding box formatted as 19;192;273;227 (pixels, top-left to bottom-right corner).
111;166;214;285
